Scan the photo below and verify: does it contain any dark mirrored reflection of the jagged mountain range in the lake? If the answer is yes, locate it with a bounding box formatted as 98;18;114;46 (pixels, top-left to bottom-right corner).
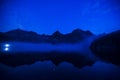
0;51;95;68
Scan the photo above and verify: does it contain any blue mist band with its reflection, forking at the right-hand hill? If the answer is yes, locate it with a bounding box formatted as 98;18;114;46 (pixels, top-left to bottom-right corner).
2;37;96;60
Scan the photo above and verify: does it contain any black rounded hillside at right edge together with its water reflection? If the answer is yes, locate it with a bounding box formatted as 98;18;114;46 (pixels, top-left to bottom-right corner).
90;30;120;65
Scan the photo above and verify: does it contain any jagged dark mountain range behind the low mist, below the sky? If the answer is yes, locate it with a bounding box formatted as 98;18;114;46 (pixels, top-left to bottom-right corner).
0;29;93;43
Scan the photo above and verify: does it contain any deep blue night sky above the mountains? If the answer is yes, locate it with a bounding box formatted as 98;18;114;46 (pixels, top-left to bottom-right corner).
0;0;120;34
